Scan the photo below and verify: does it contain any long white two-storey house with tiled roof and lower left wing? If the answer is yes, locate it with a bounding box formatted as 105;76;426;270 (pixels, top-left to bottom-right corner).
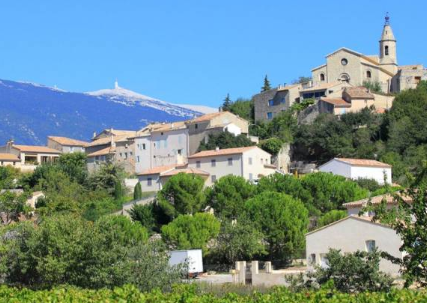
138;146;276;191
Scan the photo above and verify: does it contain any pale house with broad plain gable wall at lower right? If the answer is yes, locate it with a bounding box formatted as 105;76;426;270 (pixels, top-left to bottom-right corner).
305;215;404;276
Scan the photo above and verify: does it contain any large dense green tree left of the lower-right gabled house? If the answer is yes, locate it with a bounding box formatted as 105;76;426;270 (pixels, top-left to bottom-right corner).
246;192;308;262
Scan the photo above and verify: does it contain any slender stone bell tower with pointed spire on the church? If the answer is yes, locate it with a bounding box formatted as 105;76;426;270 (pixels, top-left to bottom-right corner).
380;13;397;74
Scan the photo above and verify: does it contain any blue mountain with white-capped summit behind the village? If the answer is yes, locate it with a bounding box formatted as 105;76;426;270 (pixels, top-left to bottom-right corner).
0;80;201;145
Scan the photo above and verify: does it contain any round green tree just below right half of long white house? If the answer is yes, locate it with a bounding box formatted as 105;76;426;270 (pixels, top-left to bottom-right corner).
206;175;256;219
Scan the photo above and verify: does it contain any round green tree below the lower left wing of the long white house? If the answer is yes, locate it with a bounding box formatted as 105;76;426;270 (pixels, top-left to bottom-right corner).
157;173;206;219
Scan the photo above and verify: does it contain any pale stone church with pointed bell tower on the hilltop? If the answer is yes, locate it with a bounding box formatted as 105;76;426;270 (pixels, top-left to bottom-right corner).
312;15;427;93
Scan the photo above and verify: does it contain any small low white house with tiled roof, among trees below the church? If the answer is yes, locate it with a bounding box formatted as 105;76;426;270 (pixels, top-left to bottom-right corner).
319;158;392;184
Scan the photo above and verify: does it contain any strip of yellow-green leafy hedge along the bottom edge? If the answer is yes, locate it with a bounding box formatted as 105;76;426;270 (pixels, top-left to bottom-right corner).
0;285;427;303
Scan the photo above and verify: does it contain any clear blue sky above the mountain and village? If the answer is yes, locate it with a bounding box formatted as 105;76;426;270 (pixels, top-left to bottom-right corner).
0;0;427;107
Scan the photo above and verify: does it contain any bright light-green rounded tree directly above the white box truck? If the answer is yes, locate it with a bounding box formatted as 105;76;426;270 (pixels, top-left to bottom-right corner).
162;213;221;254
